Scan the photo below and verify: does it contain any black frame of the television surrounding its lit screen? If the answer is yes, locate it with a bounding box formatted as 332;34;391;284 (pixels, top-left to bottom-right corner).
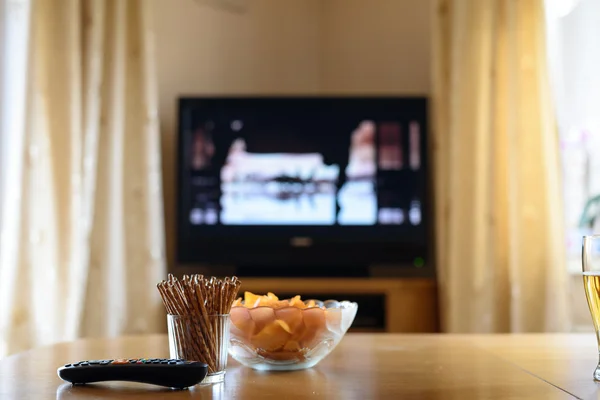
170;95;434;277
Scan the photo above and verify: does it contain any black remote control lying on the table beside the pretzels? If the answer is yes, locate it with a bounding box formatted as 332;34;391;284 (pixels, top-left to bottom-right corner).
57;358;208;389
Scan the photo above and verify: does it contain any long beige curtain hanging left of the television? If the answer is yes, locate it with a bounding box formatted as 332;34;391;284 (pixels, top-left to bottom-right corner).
0;0;165;355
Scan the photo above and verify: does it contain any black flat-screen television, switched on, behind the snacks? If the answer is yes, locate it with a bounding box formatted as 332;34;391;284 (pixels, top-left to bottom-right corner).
176;96;431;276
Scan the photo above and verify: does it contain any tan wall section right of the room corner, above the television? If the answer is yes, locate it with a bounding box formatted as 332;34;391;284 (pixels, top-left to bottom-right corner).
320;0;431;95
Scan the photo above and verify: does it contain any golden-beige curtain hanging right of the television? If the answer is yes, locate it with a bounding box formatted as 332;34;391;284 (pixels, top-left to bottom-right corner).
433;0;569;332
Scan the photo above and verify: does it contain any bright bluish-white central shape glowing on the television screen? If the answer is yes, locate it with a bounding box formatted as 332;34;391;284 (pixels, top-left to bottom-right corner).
221;121;377;225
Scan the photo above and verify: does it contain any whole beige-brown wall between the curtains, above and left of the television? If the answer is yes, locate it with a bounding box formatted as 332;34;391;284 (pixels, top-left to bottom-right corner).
152;0;431;266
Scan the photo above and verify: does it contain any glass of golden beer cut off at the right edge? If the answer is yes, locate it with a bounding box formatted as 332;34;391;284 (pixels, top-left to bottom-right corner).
582;235;600;381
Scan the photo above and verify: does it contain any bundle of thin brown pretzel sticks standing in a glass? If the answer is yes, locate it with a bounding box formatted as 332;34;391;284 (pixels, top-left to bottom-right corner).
157;274;241;373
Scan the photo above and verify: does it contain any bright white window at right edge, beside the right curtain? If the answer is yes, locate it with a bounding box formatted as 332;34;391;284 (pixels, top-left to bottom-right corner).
546;0;600;330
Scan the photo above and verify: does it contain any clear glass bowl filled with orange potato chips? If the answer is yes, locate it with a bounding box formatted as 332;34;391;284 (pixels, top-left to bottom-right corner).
229;300;358;371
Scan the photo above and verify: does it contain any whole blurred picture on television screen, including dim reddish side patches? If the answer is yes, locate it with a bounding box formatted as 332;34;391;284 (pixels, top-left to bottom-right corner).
189;109;421;226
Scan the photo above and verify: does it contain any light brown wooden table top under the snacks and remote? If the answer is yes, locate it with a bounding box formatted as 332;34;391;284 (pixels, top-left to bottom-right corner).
0;334;600;400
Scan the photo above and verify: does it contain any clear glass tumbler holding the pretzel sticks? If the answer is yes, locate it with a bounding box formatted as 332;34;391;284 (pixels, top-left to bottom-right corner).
167;314;229;384
